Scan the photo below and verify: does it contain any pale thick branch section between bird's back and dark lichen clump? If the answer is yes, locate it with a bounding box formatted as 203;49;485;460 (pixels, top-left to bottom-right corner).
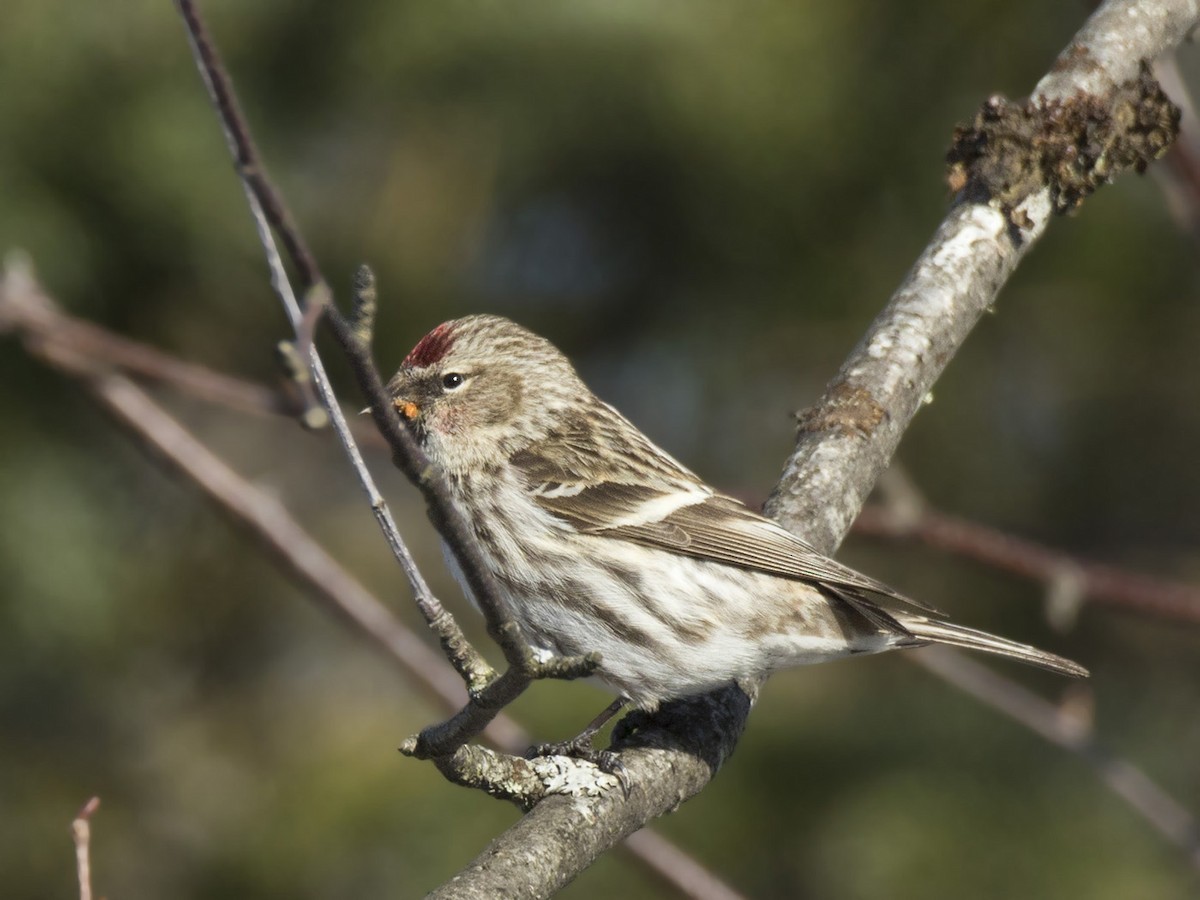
766;197;1050;552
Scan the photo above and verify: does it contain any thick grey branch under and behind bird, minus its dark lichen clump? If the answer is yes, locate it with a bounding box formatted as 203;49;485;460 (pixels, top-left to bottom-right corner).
436;0;1200;898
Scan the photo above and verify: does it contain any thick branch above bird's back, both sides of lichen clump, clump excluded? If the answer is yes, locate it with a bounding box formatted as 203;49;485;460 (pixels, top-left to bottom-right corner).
767;0;1200;551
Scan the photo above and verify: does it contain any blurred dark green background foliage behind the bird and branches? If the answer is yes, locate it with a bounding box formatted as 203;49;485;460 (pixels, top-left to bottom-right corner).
0;0;1200;900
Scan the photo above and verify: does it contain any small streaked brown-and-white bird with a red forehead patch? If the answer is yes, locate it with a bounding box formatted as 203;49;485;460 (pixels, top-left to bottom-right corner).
388;316;1087;756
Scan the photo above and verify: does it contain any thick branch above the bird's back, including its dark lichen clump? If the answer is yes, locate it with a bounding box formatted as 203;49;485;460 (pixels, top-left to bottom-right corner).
767;0;1200;550
